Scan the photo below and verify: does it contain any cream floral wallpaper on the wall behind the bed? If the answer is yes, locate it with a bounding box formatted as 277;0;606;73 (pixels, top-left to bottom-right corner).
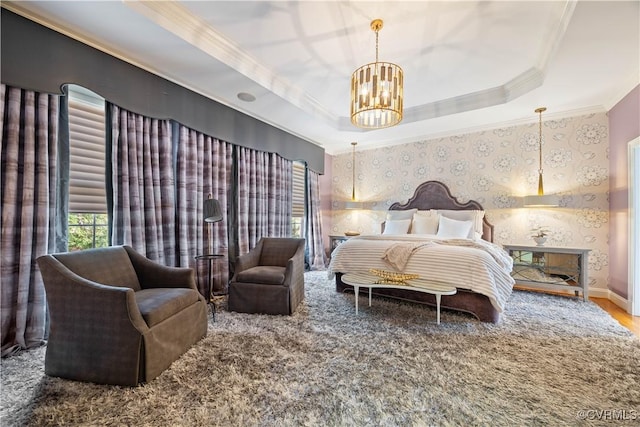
329;113;609;289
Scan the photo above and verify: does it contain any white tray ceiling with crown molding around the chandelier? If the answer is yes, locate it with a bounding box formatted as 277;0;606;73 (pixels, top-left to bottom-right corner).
2;0;640;154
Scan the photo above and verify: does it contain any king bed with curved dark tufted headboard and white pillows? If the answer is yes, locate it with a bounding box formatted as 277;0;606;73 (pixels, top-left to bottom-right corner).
329;181;514;323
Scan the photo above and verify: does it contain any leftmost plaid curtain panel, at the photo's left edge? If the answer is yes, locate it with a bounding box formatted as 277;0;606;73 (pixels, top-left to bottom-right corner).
0;84;59;357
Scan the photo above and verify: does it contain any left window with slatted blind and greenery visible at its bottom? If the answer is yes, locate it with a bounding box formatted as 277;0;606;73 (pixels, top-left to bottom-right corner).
68;85;109;251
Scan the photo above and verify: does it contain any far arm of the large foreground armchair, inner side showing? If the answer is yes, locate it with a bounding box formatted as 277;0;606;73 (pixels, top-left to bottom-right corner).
124;246;198;291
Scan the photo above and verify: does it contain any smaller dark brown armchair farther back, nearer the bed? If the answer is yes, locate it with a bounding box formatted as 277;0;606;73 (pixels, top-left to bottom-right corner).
228;237;304;314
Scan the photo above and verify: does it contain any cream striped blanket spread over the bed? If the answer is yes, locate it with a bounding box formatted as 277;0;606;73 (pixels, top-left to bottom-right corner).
329;234;514;312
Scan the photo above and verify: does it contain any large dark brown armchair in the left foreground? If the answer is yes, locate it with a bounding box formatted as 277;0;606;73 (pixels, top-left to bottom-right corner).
38;246;207;386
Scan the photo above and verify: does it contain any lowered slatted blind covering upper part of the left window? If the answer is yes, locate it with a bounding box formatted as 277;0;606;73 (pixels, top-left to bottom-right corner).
69;87;107;214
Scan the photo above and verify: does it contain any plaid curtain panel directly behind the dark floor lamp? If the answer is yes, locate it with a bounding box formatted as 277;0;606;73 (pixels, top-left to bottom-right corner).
174;123;233;291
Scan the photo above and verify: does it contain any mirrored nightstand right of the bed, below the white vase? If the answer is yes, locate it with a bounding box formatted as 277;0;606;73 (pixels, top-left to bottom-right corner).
503;245;590;301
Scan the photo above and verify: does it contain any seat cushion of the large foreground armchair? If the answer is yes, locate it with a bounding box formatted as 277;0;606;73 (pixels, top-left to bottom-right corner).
136;288;200;327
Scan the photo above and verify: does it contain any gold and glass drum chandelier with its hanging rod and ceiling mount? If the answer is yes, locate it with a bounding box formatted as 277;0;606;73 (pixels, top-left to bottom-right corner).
351;19;404;129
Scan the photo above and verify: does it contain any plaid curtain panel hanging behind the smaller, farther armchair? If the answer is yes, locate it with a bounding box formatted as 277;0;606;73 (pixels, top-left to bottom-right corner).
237;147;293;255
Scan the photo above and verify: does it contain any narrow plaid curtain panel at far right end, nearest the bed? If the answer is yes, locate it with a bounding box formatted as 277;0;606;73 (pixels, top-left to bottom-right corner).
303;168;327;270
